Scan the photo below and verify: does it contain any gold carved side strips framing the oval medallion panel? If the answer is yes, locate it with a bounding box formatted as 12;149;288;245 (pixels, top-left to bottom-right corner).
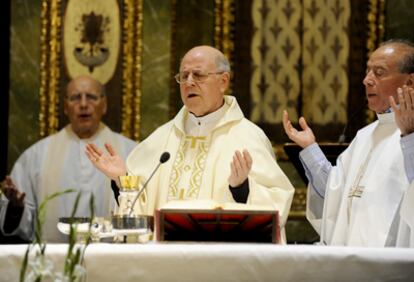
39;0;143;140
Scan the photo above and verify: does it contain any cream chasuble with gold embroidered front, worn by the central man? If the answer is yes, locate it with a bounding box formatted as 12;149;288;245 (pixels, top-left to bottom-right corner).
127;96;294;235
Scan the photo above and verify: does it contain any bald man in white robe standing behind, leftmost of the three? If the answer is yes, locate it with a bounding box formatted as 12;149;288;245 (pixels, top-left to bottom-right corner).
0;76;136;242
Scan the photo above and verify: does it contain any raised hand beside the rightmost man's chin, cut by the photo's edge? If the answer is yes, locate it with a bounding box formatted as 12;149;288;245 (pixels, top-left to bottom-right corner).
389;85;414;136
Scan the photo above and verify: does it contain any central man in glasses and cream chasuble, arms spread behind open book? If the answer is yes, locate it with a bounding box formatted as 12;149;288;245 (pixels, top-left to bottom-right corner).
87;46;294;240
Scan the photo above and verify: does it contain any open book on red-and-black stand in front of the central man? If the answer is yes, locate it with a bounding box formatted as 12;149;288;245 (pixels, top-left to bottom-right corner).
155;200;280;243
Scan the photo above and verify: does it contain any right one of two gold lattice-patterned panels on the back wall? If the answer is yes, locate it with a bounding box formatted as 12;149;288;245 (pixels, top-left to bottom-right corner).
302;0;350;125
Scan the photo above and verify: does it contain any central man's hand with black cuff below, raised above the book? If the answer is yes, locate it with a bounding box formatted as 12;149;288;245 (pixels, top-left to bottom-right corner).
229;150;253;187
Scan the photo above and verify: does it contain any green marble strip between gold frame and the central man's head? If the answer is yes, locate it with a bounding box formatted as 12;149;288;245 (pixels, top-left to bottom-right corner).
141;0;171;139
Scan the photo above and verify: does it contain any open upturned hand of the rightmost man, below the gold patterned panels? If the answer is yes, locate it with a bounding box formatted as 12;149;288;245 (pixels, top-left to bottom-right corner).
283;111;315;148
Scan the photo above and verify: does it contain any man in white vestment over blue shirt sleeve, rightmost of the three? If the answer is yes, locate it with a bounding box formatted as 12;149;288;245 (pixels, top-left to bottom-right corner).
283;40;414;247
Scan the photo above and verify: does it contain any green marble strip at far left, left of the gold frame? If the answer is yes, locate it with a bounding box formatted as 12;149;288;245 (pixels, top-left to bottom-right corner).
8;0;40;171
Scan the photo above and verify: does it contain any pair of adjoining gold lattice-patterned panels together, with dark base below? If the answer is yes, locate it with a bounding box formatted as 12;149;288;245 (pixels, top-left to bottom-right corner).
250;0;350;143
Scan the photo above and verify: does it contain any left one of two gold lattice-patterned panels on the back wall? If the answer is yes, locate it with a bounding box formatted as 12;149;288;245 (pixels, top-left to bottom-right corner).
250;0;302;124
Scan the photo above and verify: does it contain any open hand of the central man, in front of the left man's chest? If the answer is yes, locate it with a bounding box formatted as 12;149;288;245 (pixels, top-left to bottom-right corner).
85;143;126;181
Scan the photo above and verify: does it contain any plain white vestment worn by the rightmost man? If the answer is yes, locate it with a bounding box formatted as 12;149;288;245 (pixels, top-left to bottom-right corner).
307;113;408;247
